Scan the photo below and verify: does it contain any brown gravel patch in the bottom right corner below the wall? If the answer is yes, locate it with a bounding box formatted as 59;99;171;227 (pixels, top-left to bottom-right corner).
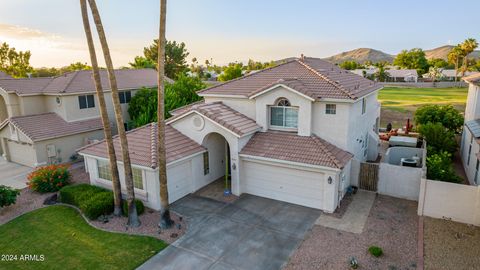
423;217;480;270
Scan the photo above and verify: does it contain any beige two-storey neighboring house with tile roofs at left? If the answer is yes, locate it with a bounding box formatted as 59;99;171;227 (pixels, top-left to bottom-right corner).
0;69;157;167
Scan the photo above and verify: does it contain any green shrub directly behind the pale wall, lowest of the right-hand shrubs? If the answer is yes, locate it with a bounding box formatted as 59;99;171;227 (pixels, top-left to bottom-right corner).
427;151;460;183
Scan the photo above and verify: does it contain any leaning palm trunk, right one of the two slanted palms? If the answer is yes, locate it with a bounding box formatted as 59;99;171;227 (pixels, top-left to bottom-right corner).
88;0;140;227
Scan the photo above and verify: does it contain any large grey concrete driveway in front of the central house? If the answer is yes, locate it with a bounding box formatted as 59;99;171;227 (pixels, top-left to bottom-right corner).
139;194;320;270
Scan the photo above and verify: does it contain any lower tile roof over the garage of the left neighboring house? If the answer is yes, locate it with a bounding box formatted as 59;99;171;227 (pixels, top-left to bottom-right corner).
3;113;103;142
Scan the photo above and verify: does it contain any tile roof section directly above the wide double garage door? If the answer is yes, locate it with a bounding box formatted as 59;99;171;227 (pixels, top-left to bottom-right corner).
240;131;353;169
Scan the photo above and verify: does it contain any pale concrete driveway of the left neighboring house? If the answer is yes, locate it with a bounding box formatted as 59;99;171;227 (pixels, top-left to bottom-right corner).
0;157;32;189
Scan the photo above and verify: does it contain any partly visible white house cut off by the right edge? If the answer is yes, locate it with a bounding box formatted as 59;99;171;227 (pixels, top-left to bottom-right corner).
460;73;480;185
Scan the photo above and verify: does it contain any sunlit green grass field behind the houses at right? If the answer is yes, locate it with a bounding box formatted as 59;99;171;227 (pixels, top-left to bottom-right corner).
378;87;467;127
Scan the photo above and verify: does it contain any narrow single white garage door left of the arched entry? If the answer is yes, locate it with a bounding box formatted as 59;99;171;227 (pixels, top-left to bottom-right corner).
167;160;193;203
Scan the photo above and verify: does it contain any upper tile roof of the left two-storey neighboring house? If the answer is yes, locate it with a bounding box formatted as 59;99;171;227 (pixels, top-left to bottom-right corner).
0;69;169;95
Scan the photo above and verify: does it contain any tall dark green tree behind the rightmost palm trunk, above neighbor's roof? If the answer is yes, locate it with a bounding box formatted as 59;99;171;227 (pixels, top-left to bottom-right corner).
143;39;190;79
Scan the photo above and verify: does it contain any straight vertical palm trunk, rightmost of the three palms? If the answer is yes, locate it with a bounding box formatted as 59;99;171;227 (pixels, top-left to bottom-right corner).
157;0;173;229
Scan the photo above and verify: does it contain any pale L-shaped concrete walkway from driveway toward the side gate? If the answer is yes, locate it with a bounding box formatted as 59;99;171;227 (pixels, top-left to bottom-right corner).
315;190;376;233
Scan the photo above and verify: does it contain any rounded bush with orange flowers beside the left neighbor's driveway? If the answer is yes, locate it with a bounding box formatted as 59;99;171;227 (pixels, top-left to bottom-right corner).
28;165;71;193
